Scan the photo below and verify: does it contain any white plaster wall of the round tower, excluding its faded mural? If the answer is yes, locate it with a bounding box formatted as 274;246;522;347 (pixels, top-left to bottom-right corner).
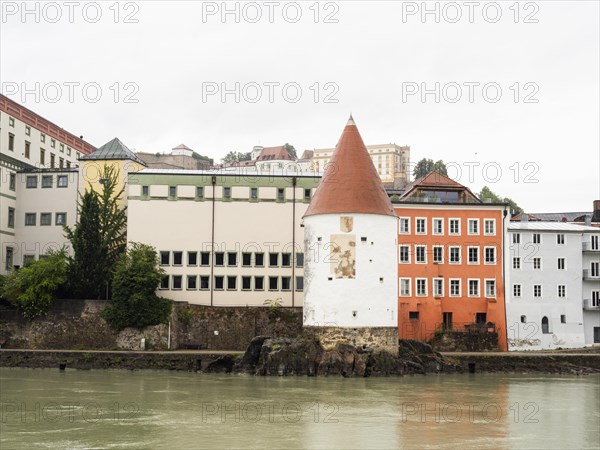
304;214;398;327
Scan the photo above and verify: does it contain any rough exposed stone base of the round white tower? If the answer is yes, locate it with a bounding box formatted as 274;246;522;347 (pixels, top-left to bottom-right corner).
304;327;398;355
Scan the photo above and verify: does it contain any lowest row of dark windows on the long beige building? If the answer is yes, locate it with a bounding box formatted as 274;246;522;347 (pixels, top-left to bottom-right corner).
160;275;304;292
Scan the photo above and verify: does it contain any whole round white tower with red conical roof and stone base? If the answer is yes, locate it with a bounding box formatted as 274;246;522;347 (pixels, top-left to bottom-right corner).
303;116;398;354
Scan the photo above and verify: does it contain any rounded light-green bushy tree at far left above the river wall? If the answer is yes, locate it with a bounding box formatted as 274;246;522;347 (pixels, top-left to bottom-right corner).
2;248;67;319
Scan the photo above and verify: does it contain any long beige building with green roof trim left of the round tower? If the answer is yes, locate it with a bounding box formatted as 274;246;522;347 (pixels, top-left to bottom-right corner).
127;168;320;306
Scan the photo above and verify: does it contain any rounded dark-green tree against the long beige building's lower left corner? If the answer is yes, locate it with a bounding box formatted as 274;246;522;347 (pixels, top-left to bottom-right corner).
103;242;172;330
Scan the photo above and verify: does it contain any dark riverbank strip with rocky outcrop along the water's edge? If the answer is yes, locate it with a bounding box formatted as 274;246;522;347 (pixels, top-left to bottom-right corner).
0;337;600;377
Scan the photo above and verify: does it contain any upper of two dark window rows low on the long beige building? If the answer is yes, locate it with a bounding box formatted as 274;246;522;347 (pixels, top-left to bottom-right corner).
159;251;304;267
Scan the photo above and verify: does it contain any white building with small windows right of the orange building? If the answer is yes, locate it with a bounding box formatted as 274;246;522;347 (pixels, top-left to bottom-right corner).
506;222;600;350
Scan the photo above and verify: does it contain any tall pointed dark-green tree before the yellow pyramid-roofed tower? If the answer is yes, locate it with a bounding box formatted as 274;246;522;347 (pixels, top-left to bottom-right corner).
64;165;127;298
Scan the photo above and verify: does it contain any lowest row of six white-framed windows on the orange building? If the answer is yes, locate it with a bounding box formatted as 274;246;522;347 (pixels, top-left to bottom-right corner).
400;278;496;298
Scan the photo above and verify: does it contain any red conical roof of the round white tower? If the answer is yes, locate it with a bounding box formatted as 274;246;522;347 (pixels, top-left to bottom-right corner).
304;116;396;217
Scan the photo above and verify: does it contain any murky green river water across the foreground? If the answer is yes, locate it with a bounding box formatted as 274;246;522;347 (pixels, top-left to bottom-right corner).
0;369;600;450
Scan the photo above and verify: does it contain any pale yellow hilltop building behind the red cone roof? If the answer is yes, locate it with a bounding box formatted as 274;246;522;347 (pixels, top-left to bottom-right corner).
312;144;410;187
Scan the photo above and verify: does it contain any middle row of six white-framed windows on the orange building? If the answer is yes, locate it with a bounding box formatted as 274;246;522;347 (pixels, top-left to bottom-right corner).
398;244;496;264
